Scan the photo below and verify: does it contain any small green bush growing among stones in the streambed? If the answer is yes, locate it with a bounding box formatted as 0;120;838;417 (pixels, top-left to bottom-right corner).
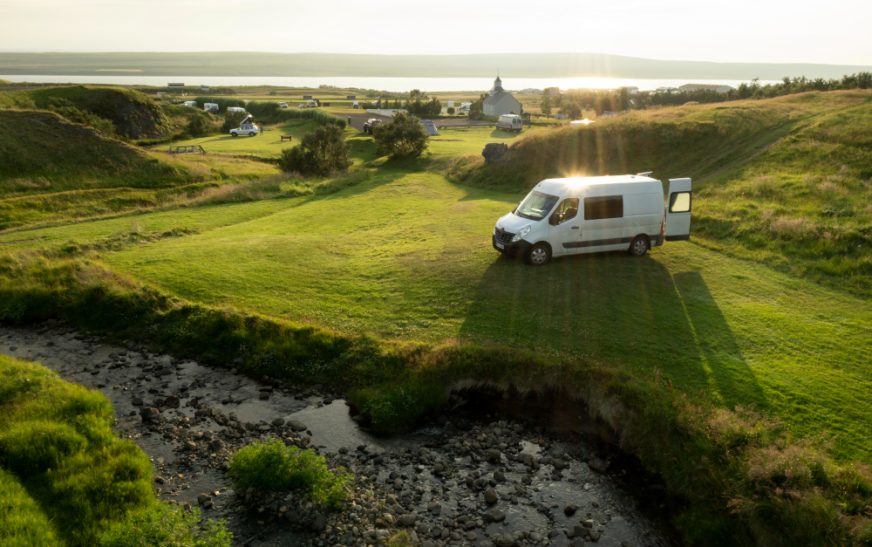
228;438;349;509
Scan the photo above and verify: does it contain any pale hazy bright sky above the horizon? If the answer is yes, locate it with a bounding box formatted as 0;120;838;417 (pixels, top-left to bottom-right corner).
0;0;872;66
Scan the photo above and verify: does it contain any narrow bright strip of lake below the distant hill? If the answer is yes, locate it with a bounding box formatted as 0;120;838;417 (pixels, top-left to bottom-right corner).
0;72;779;92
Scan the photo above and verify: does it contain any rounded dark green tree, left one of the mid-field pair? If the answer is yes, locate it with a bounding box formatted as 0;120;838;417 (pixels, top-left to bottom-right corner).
279;124;351;176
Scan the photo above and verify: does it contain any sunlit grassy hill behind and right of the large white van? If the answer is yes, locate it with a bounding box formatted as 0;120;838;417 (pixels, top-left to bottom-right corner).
454;91;872;296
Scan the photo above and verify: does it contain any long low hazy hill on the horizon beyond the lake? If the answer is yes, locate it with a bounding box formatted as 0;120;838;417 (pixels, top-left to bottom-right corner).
0;52;872;80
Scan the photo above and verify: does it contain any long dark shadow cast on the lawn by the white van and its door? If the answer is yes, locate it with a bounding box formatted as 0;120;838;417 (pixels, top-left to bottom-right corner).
459;253;767;409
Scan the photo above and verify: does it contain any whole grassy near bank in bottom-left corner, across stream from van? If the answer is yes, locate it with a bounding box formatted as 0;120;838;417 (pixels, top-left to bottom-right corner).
0;356;228;545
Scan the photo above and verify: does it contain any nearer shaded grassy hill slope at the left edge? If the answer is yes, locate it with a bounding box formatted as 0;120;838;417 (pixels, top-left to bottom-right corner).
0;110;191;229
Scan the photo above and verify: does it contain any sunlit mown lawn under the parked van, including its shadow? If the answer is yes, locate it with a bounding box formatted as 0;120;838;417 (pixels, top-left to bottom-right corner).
76;167;872;462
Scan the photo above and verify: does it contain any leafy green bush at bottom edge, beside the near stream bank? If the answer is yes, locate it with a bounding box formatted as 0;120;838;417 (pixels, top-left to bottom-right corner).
100;503;233;547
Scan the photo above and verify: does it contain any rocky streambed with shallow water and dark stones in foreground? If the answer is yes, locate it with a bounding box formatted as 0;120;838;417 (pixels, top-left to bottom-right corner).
0;326;671;546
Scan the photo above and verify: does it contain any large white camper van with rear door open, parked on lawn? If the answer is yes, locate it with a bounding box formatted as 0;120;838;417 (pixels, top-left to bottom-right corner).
493;174;692;265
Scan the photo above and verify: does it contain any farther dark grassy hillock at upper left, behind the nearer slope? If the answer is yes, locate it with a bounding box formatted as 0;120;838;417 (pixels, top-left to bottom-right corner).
0;86;172;140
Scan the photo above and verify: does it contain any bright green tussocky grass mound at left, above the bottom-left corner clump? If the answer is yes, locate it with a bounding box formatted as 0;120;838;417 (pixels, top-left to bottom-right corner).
0;356;154;544
